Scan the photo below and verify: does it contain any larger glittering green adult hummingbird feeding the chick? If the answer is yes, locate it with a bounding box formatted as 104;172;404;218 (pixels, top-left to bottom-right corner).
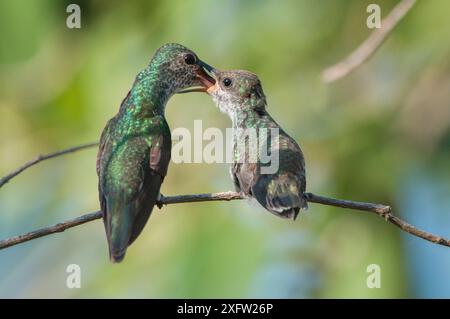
97;43;214;262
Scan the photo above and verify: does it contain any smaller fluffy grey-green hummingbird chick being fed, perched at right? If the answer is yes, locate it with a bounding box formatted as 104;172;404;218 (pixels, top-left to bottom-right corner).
207;68;308;220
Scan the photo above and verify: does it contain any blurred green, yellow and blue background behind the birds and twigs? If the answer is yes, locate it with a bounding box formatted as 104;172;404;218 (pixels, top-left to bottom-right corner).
0;0;450;298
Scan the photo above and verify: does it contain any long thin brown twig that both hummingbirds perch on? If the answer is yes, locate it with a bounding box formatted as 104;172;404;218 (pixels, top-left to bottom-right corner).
0;192;450;250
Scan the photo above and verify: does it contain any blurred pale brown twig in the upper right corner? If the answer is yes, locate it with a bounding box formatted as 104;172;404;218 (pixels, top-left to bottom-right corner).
322;0;416;83
